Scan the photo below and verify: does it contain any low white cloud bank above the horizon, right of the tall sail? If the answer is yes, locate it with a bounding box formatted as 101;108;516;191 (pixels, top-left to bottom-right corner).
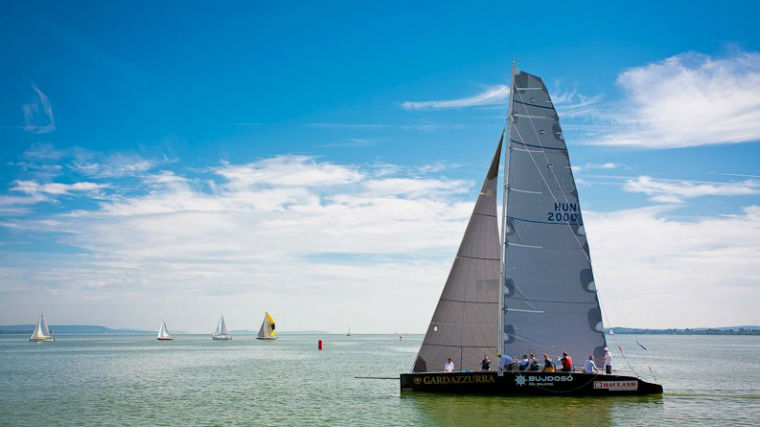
585;206;760;328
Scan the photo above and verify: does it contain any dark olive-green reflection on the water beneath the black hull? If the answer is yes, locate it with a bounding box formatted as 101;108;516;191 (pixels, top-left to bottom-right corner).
401;392;662;426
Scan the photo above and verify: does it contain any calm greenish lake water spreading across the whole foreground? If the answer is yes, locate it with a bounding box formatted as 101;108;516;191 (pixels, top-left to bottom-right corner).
0;335;760;426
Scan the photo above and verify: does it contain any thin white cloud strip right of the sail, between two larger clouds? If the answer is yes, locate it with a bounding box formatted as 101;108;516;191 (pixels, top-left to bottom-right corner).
623;176;760;203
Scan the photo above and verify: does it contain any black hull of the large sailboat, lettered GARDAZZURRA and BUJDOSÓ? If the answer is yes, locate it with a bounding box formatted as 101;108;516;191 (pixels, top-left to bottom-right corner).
401;372;662;396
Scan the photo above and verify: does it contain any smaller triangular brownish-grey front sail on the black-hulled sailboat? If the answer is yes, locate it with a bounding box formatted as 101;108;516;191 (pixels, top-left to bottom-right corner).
412;133;504;372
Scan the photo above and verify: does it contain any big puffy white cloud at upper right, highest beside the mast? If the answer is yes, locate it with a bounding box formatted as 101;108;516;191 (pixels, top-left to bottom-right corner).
591;52;760;148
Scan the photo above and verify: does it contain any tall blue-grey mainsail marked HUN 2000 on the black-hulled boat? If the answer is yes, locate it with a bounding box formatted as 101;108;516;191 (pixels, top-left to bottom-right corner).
502;69;606;364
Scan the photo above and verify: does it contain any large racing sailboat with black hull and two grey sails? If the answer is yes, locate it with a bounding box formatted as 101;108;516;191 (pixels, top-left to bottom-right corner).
400;67;662;395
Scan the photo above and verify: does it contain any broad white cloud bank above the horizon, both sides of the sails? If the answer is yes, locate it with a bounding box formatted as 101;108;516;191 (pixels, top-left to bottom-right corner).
0;156;760;332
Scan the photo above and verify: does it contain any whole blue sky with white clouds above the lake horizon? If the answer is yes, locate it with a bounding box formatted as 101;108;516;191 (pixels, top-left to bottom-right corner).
0;1;760;333
